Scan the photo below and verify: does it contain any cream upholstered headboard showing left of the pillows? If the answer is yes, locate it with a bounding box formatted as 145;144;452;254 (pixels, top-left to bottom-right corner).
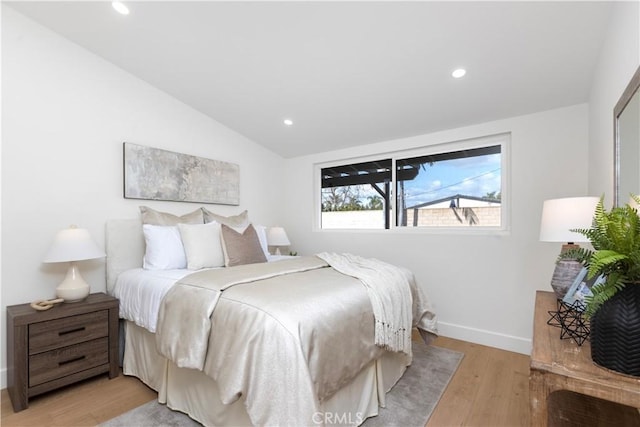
105;219;144;295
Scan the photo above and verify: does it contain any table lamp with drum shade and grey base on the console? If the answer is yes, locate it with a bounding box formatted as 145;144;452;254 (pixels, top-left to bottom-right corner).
540;197;600;299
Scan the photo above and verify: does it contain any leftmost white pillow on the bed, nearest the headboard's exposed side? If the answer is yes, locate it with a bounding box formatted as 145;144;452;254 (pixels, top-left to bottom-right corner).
142;224;187;270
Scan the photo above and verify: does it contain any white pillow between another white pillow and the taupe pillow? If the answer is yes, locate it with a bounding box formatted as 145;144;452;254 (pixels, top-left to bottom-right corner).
178;222;224;270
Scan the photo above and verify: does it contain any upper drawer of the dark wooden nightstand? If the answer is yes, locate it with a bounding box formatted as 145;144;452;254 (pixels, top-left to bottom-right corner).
29;310;109;355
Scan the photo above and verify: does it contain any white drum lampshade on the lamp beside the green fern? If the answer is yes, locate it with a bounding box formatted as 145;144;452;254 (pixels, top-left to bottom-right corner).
540;197;600;242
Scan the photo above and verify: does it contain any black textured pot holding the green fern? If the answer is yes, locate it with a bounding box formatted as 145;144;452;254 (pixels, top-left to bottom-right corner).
590;283;640;376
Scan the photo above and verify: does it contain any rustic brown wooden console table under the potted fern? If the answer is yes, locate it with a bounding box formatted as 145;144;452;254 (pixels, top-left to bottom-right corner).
529;291;640;426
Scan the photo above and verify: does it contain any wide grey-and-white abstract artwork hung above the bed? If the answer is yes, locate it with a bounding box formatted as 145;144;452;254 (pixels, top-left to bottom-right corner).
123;142;240;205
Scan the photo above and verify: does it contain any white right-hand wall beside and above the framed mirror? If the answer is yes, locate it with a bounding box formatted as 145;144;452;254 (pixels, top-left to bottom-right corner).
589;1;640;204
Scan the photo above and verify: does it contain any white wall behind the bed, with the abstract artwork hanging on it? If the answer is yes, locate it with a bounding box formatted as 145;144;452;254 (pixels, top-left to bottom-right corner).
0;4;282;387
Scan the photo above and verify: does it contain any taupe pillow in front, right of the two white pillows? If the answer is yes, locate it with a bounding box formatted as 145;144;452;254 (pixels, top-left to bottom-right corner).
221;224;267;267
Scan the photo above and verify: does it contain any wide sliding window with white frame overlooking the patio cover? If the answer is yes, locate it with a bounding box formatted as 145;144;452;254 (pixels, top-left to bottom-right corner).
319;134;509;229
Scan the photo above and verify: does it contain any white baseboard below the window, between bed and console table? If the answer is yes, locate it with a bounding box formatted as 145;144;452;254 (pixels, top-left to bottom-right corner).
438;322;531;355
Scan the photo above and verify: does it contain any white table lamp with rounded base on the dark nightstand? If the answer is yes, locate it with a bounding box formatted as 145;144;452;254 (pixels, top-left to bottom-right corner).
43;225;106;302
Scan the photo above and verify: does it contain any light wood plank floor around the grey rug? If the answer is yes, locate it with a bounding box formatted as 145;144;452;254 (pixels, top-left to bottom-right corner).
0;337;529;427
